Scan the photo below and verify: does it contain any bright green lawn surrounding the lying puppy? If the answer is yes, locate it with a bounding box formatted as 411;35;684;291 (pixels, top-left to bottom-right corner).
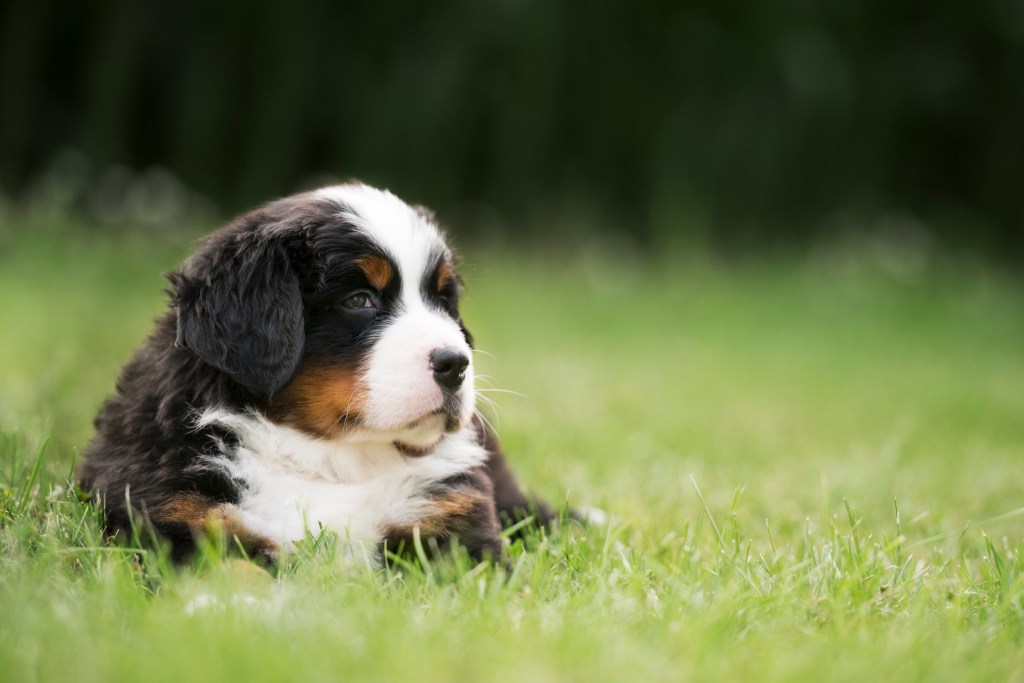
0;211;1024;682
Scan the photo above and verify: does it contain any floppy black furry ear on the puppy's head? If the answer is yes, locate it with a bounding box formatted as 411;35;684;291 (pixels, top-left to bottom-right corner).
169;233;305;398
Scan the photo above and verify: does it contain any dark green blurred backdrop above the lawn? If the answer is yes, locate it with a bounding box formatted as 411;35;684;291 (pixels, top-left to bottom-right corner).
0;0;1024;262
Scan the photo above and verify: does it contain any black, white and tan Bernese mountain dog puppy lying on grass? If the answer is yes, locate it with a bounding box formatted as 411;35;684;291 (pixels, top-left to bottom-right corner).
79;183;554;561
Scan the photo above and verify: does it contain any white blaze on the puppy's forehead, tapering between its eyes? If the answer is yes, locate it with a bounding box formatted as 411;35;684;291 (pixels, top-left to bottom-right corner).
315;184;444;303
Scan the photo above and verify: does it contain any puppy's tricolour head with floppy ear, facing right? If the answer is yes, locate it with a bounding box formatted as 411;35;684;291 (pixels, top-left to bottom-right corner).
170;184;475;454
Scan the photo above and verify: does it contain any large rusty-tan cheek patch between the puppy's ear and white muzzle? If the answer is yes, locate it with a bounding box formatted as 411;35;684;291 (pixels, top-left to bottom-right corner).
267;366;367;437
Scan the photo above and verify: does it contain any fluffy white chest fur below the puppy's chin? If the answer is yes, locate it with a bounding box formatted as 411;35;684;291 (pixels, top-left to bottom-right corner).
199;411;486;549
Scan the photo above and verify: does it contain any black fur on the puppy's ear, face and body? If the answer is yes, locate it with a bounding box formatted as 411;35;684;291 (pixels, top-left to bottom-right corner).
79;188;553;559
